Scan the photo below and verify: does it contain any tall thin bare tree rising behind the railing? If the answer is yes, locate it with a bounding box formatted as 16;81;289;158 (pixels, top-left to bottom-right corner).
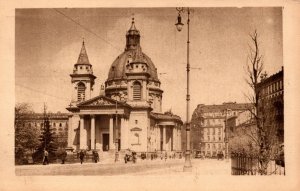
246;30;276;175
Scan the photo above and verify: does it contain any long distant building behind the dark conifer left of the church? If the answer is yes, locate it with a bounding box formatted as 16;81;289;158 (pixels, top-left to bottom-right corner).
23;113;68;147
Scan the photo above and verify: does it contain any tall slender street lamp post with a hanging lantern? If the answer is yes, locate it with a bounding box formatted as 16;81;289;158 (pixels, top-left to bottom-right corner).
175;8;192;171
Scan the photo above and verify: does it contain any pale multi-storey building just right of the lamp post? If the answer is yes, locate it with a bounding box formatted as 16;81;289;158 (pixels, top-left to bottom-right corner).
191;102;252;157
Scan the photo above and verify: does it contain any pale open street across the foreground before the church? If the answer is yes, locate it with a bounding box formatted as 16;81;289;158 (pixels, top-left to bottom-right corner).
15;159;230;176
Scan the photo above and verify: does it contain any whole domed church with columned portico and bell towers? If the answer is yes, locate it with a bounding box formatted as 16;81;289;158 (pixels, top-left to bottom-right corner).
67;19;182;157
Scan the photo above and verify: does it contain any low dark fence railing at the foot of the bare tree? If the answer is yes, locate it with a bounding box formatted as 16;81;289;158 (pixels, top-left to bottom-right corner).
231;153;285;175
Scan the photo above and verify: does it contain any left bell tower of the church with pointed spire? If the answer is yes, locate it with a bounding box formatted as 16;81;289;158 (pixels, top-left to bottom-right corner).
70;40;96;104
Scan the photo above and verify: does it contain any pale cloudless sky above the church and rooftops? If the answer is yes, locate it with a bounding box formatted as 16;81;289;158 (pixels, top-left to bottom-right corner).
15;7;283;120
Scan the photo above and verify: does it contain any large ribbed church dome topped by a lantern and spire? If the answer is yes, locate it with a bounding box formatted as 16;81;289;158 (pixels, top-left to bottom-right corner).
106;20;159;82
